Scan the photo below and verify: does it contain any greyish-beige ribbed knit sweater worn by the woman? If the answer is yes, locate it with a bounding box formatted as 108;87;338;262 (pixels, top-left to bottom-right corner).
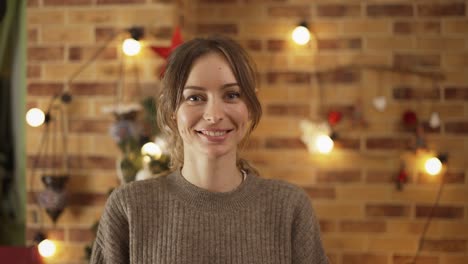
91;171;328;264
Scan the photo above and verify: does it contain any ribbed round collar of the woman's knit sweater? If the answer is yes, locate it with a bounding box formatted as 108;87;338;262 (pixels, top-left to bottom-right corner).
167;170;259;212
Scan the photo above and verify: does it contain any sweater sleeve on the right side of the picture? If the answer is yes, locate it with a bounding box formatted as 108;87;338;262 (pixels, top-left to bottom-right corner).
291;190;329;264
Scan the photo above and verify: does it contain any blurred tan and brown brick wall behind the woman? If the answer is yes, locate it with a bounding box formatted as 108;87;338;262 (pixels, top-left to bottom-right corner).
27;0;468;264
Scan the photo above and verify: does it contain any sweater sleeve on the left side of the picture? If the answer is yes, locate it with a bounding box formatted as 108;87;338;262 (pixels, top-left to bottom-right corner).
90;189;130;264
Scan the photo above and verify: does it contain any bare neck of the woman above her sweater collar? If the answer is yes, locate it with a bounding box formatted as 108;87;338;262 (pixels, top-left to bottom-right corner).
181;153;243;192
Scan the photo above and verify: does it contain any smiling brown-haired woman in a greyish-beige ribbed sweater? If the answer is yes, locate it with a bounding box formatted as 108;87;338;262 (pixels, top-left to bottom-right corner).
91;37;328;264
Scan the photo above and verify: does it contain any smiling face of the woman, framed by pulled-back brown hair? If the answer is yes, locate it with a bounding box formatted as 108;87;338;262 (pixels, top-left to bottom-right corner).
176;52;249;158
